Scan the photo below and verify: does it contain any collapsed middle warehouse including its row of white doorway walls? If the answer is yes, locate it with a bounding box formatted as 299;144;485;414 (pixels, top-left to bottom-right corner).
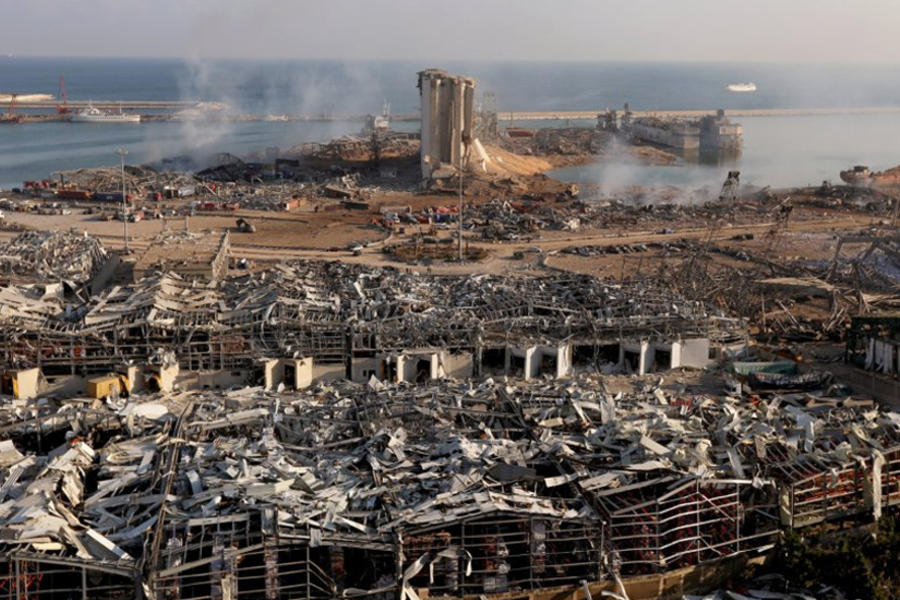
0;262;747;397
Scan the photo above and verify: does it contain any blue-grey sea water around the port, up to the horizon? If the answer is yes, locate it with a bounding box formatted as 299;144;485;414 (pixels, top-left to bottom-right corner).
0;57;900;187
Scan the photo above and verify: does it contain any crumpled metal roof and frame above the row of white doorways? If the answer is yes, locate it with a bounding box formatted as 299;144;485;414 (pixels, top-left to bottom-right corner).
0;262;746;374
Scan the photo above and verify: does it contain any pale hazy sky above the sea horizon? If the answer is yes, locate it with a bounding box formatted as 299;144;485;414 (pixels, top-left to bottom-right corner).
0;0;900;63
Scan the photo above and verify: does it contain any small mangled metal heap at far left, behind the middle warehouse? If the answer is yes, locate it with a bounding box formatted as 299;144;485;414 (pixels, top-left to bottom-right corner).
0;231;108;283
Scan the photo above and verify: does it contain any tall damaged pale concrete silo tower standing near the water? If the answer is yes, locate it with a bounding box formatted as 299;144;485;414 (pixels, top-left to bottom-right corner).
419;69;475;179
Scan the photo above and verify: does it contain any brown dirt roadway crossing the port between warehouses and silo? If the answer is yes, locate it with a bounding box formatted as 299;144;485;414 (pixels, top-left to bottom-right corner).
0;202;872;274
